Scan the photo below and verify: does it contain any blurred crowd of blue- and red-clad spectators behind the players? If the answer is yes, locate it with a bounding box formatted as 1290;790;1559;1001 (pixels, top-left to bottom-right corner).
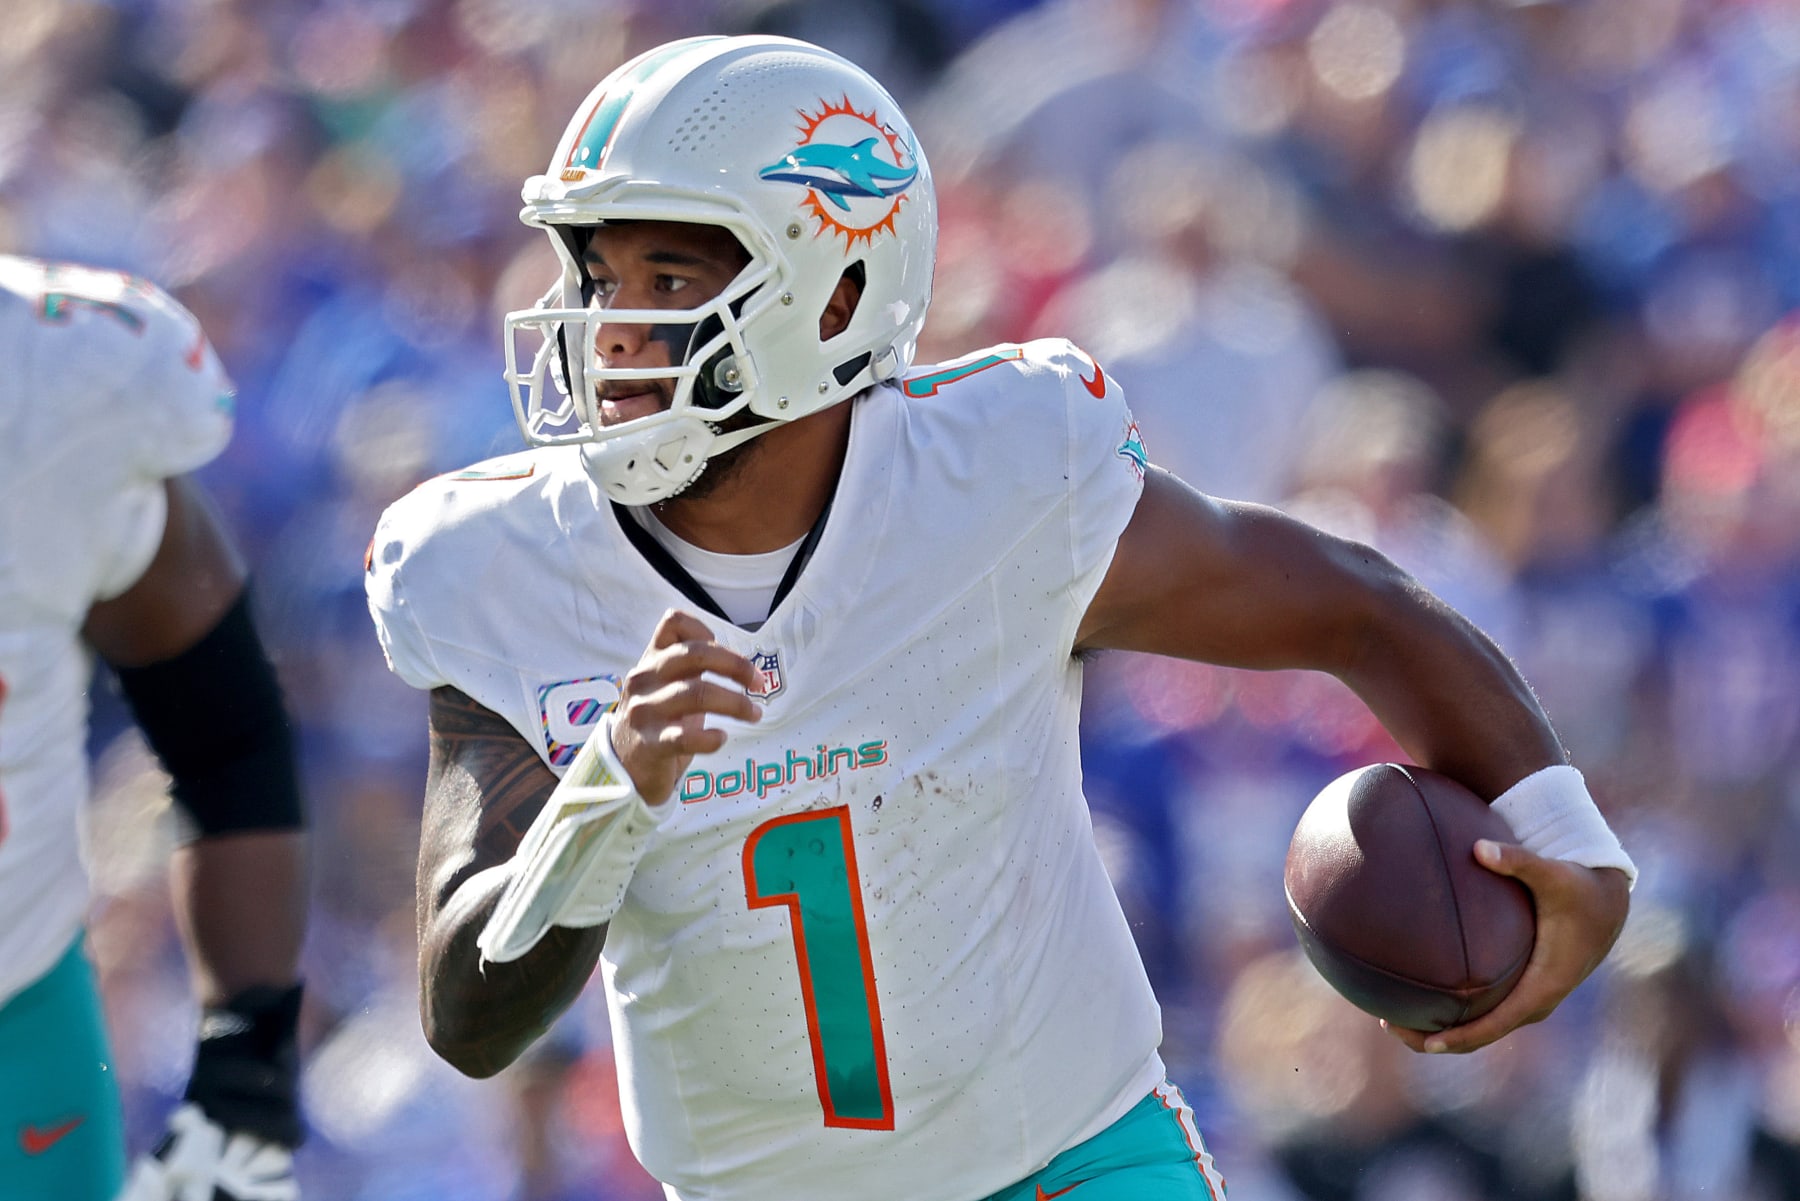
14;0;1800;1201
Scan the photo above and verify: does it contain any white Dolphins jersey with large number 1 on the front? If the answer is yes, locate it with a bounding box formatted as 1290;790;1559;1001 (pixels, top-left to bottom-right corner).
369;340;1163;1201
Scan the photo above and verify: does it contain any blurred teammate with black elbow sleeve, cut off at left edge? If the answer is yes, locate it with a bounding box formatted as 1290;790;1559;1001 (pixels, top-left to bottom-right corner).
0;257;304;1201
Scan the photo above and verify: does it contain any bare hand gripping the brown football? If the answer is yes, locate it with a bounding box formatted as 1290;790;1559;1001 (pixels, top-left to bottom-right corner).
1382;839;1631;1053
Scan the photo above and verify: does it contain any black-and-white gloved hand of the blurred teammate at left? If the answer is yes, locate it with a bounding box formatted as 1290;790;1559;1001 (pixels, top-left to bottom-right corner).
119;985;302;1201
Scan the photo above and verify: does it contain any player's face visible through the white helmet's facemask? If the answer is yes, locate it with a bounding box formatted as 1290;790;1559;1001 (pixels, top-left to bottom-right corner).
583;221;749;425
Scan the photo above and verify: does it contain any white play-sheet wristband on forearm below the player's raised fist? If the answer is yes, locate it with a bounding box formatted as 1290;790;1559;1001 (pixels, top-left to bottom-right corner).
477;713;671;963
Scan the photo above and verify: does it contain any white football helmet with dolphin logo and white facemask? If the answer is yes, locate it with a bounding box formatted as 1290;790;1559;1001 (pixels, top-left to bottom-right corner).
506;38;938;504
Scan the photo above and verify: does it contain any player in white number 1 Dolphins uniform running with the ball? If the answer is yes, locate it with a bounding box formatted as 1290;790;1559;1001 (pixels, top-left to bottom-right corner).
369;38;1629;1201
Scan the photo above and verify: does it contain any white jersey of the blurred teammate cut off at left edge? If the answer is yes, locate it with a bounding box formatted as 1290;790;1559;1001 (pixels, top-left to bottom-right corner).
0;256;232;1001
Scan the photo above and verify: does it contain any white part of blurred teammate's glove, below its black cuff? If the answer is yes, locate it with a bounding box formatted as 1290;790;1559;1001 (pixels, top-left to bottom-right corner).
119;1104;301;1201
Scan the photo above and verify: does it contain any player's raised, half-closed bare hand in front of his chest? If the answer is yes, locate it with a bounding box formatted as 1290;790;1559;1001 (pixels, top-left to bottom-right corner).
612;609;761;805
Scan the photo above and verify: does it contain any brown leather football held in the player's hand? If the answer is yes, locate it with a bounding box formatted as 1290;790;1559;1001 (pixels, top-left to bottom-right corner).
1285;763;1537;1030
